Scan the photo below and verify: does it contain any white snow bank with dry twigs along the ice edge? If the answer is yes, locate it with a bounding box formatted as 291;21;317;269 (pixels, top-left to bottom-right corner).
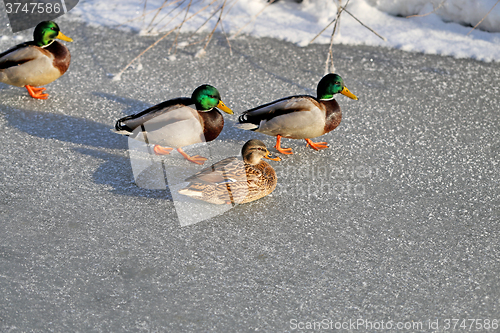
63;0;500;61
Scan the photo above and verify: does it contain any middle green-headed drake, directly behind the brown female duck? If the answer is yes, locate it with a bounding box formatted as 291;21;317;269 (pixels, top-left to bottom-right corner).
113;84;233;165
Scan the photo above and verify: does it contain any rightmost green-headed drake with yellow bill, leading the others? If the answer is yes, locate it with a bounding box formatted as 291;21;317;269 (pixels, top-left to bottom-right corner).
236;74;358;154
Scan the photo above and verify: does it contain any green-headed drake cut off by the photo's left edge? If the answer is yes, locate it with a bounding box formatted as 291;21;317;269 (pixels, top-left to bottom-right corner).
0;21;73;99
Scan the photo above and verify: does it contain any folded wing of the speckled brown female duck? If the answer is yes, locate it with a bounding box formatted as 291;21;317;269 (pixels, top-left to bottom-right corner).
185;157;246;184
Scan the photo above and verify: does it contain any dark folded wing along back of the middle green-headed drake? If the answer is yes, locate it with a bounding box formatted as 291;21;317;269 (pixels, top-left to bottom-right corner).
115;97;192;135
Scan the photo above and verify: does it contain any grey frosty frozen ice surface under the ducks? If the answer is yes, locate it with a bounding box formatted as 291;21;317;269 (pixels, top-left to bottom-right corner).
0;17;500;332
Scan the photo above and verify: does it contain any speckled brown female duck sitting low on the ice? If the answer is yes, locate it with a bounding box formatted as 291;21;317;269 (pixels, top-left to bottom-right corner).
178;140;280;204
